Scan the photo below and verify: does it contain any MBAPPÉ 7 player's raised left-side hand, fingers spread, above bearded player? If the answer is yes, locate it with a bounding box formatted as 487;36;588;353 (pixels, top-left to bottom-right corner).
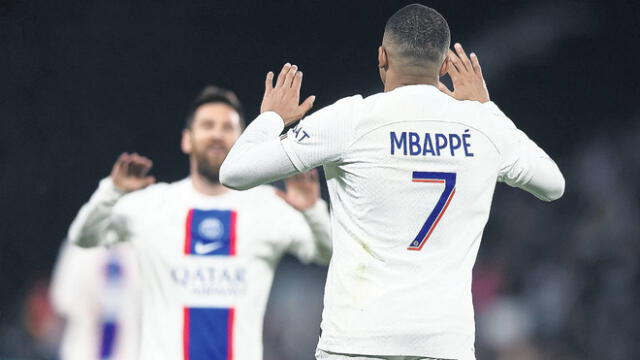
260;63;316;126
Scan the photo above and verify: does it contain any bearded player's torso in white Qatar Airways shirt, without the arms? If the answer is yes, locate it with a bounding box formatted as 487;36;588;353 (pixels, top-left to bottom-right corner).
122;183;283;360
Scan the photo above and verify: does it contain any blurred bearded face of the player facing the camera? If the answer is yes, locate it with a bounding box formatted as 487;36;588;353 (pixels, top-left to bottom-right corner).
182;103;242;183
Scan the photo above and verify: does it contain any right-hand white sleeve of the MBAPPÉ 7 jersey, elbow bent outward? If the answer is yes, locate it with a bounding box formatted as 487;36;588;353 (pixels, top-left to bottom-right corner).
484;102;565;201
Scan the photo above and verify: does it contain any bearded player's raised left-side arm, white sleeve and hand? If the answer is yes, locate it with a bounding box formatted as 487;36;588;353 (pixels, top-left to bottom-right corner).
68;153;155;247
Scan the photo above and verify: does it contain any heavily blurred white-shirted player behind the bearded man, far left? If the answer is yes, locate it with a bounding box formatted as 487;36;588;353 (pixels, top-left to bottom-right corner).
50;243;140;360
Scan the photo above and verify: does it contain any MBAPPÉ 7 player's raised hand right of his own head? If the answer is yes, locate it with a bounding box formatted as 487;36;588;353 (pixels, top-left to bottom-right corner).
438;44;489;103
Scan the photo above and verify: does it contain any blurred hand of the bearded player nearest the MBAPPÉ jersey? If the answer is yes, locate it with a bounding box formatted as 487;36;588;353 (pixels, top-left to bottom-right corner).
276;169;320;211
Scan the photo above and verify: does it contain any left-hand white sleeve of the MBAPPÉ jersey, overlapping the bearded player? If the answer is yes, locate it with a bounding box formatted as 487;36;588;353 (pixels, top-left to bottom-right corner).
220;96;362;190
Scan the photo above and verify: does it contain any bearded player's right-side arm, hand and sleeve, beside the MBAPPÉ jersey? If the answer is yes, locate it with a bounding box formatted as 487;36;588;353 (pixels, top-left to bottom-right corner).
277;170;331;264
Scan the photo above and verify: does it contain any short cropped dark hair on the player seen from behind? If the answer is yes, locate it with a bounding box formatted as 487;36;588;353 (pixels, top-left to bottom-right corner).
384;4;451;65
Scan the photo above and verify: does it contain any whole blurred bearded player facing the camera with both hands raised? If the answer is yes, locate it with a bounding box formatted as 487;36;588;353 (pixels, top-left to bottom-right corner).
68;87;331;360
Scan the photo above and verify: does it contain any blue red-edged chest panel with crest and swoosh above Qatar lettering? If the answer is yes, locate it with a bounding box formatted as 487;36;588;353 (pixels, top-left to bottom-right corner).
184;209;236;256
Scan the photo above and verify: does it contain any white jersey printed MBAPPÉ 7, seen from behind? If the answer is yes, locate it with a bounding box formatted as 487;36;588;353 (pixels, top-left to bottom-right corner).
268;85;564;360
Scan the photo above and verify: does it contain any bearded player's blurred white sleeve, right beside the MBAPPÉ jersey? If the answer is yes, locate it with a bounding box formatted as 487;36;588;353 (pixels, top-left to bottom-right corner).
283;199;331;265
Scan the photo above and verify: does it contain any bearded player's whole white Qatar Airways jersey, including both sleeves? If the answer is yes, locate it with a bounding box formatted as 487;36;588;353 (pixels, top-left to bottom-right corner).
69;178;330;360
